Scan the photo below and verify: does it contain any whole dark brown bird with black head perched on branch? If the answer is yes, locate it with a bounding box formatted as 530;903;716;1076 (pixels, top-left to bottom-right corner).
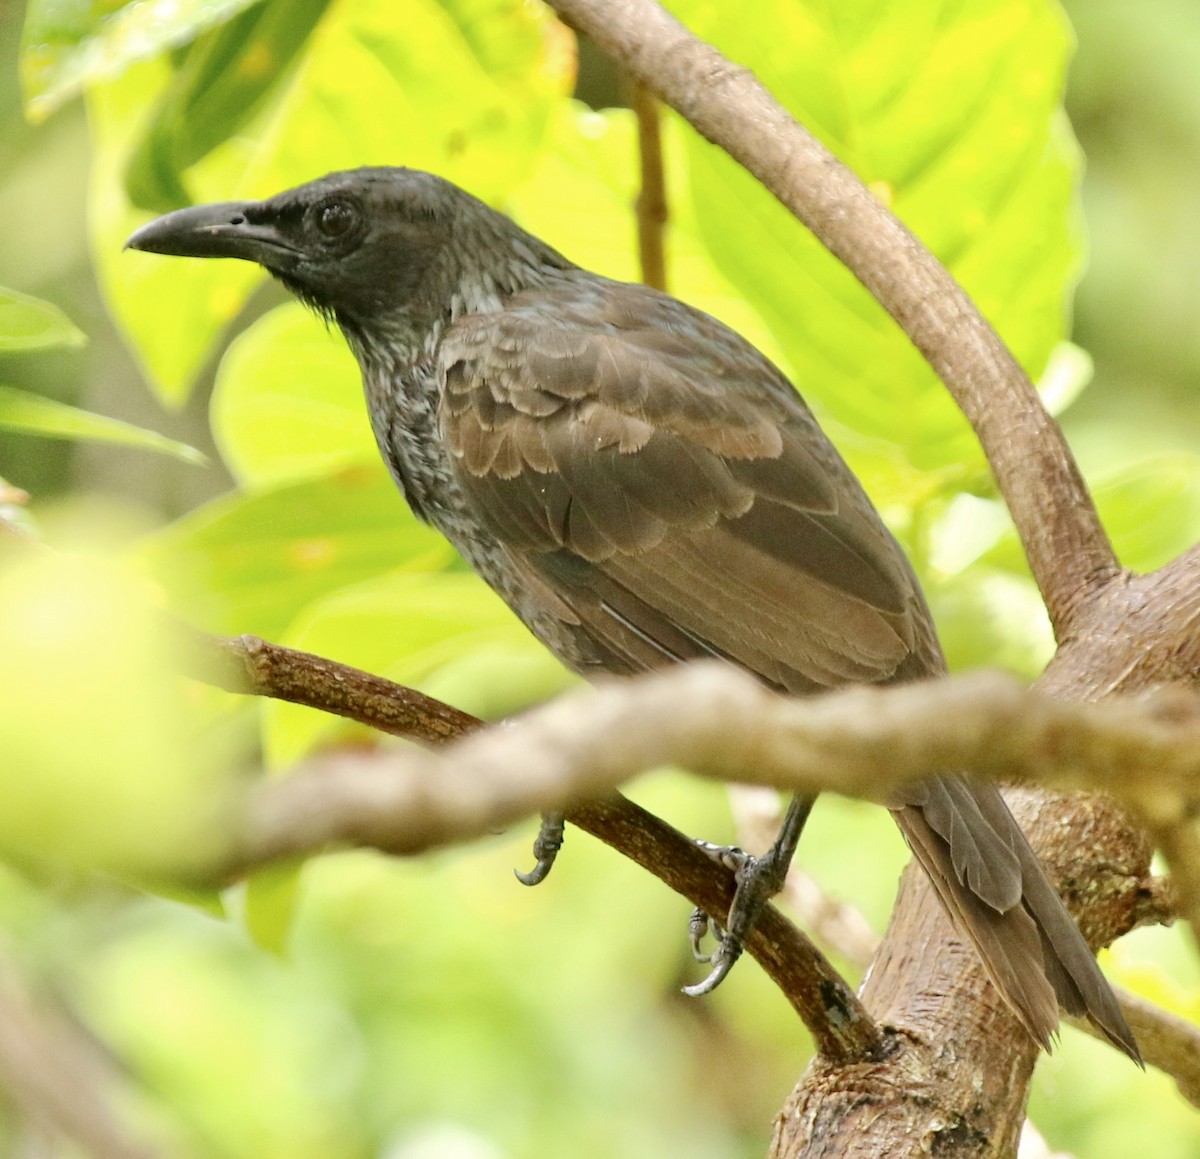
128;168;1138;1059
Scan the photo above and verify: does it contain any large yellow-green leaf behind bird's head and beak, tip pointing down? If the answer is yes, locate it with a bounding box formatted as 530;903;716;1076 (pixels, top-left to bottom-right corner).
91;0;574;400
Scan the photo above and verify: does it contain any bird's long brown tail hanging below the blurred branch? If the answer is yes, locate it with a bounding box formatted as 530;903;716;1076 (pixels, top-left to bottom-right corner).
894;776;1141;1065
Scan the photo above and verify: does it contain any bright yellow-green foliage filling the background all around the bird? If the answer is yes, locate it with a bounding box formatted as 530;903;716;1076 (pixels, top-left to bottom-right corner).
0;0;1200;1159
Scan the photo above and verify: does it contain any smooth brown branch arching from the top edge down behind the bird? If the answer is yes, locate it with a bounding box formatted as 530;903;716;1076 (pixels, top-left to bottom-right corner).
550;0;1118;639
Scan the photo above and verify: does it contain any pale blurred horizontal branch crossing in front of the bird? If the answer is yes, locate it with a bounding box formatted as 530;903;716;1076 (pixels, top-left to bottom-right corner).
196;641;1200;864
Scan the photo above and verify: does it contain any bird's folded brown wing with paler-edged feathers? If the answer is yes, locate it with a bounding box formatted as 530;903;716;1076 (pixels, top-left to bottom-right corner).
440;283;938;692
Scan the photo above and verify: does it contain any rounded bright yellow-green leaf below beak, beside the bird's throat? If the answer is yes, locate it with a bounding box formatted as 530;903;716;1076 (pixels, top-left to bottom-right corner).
212;304;379;487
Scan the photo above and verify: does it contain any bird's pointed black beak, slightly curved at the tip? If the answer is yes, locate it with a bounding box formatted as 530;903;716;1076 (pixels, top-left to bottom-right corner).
125;202;295;266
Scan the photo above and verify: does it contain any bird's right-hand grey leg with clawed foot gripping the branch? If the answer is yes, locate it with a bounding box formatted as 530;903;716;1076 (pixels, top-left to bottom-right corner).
683;797;815;998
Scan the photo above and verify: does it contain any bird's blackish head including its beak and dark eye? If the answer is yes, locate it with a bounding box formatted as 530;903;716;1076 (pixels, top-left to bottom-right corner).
126;168;565;329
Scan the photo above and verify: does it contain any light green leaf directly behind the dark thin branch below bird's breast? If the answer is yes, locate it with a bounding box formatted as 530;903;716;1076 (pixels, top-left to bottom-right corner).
264;572;575;767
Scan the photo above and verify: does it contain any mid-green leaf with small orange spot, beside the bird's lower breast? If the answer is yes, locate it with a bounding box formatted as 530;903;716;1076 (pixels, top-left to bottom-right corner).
138;463;457;639
